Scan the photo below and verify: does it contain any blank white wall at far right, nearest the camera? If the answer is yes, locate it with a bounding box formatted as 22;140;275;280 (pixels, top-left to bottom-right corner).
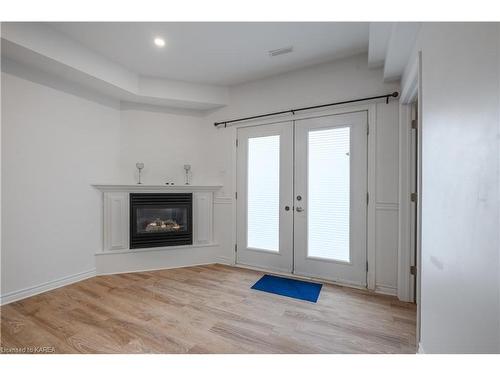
402;23;500;353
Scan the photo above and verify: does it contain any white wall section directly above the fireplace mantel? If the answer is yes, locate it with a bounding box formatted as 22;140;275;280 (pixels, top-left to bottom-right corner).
119;108;221;185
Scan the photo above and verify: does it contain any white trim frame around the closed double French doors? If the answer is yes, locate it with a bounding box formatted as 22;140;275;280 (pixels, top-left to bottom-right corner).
229;103;377;291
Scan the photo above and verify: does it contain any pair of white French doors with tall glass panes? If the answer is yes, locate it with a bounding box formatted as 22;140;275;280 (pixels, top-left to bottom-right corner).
236;111;367;286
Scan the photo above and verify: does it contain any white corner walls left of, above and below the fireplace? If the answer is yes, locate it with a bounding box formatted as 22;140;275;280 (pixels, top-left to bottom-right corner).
1;71;227;303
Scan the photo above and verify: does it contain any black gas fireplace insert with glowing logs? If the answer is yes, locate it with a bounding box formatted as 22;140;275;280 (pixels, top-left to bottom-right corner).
130;193;193;249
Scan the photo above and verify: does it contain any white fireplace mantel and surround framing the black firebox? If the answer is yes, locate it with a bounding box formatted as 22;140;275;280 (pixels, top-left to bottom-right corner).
92;184;222;253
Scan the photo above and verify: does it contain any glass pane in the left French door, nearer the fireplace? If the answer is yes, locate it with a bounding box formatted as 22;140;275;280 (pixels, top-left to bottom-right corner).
247;135;280;252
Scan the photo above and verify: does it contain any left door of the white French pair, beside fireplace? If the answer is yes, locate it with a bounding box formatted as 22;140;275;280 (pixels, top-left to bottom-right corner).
236;122;293;272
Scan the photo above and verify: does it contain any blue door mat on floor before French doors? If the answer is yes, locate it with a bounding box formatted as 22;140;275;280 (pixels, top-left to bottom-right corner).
252;275;323;302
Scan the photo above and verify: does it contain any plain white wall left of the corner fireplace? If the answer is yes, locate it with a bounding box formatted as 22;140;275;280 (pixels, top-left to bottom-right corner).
1;73;120;297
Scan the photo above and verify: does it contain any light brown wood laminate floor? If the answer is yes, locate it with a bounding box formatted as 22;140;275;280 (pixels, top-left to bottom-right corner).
0;265;416;353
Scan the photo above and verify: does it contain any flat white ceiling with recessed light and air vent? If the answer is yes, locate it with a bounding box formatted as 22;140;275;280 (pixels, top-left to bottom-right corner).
49;22;369;85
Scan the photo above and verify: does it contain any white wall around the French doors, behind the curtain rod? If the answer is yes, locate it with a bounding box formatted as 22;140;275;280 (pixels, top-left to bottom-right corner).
205;55;399;294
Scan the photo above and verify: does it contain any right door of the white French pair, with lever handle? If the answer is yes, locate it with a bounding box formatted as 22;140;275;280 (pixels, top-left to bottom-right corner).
294;112;368;286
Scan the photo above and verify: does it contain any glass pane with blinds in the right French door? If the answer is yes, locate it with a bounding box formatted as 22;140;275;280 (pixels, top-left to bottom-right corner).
307;127;350;262
